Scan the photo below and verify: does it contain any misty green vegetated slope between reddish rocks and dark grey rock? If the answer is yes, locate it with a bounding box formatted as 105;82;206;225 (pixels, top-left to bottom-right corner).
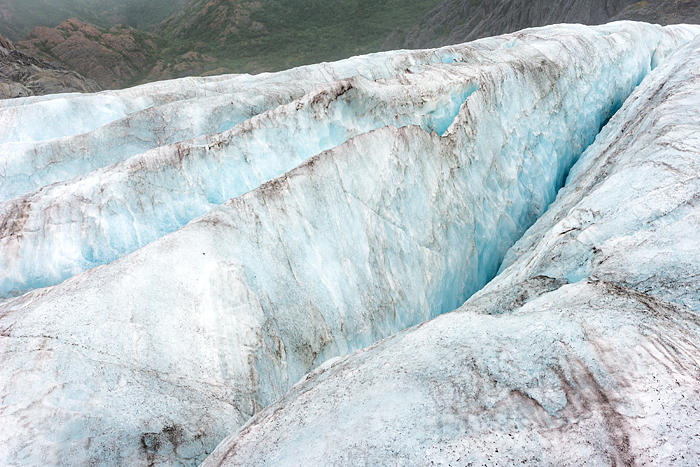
160;0;439;72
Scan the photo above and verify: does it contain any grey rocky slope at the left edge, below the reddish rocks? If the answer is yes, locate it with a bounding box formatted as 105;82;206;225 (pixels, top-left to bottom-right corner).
0;31;100;99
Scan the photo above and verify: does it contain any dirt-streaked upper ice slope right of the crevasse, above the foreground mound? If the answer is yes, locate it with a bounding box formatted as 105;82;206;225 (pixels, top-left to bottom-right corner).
488;36;700;311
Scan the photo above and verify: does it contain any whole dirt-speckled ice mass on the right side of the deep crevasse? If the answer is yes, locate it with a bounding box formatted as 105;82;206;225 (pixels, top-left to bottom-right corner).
202;33;700;467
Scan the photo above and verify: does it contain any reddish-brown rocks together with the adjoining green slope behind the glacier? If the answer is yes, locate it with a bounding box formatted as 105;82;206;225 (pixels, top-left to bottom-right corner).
6;0;437;89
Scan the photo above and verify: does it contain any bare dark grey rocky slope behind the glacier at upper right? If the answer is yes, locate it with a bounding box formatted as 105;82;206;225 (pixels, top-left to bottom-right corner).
384;0;700;50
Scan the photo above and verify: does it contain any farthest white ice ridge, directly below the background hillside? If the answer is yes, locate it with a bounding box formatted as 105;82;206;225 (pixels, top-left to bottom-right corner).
0;38;516;195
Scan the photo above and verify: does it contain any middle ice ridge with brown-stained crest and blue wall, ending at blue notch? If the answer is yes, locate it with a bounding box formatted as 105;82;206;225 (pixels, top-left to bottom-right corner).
0;75;476;296
